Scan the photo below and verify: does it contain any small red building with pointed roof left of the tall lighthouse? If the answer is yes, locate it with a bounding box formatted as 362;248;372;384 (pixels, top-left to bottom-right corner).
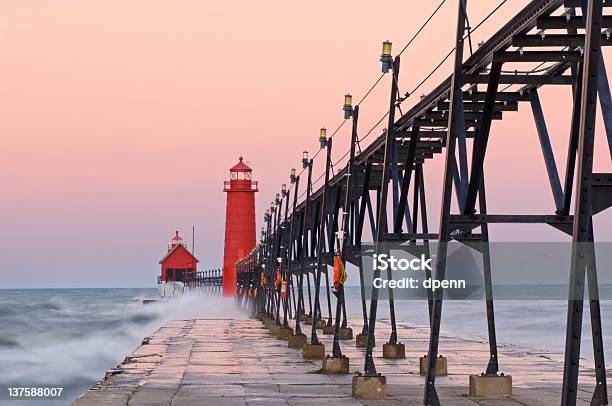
159;231;199;282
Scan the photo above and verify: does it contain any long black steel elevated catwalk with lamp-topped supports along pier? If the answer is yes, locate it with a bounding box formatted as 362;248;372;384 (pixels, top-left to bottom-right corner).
232;0;612;405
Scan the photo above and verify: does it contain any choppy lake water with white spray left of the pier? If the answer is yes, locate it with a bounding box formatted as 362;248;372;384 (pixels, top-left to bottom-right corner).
0;289;242;406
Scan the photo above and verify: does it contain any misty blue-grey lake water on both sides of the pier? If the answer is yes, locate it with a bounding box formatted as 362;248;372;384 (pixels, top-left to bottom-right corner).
0;286;612;405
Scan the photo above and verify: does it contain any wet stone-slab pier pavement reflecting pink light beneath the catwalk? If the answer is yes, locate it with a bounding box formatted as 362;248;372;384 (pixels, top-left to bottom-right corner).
73;319;610;406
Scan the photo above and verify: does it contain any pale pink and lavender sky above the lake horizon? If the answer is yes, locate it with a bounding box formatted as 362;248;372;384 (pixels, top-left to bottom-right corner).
0;0;612;287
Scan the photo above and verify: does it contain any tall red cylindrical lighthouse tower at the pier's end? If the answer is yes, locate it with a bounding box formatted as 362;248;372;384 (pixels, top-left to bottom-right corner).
223;157;258;296
